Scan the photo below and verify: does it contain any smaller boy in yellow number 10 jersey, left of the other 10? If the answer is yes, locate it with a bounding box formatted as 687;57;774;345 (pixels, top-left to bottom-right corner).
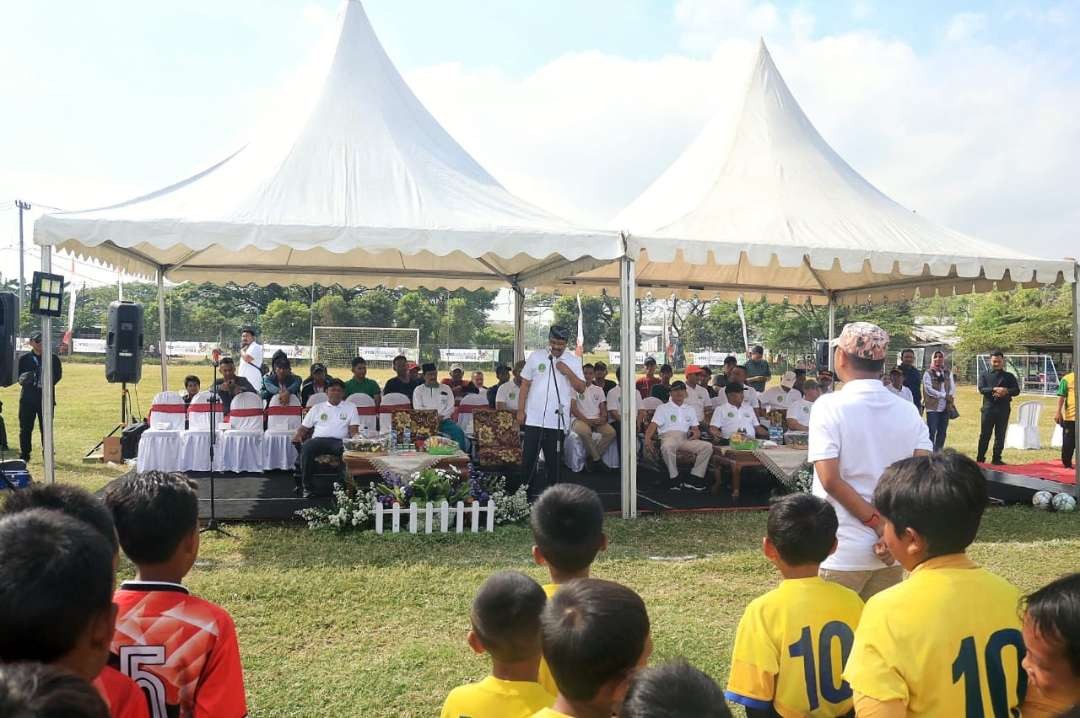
725;493;863;718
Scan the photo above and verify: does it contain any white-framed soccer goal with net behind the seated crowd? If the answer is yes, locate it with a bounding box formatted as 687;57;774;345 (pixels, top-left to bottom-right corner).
311;326;420;369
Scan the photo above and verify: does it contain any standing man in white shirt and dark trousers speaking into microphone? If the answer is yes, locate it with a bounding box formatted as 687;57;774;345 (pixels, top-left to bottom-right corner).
517;325;585;498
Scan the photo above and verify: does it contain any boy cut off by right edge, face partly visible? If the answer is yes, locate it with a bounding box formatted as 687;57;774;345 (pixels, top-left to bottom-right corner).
1024;573;1080;718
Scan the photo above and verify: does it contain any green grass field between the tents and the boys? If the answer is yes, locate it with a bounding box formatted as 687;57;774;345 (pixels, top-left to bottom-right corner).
0;364;1080;717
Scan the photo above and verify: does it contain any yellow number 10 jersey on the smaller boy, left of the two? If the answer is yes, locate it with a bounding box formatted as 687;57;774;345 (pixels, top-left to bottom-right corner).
725;577;863;718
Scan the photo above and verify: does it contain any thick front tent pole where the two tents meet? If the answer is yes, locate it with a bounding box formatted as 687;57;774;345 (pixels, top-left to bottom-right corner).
619;244;638;518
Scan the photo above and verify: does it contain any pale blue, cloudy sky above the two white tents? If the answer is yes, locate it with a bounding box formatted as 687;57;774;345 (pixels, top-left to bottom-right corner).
0;0;1080;285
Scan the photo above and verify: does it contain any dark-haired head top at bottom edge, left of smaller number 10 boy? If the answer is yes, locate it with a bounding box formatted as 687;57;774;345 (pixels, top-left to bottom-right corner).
619;659;731;718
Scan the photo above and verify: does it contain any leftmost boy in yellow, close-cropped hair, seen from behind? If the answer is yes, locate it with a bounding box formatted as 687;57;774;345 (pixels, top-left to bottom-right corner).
442;571;555;718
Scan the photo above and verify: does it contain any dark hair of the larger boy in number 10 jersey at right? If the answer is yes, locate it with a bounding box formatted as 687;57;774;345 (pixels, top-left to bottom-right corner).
874;449;987;557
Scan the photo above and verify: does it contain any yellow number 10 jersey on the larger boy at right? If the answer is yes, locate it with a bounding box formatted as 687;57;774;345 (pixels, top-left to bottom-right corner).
843;554;1027;718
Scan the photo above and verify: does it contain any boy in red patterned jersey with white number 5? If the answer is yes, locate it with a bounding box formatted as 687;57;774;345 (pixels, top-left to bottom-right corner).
105;472;247;718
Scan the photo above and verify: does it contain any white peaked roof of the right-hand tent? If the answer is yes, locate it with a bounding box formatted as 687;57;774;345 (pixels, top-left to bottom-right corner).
570;42;1074;302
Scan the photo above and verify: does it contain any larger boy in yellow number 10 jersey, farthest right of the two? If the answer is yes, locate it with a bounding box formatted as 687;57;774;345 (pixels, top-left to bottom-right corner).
843;450;1027;718
